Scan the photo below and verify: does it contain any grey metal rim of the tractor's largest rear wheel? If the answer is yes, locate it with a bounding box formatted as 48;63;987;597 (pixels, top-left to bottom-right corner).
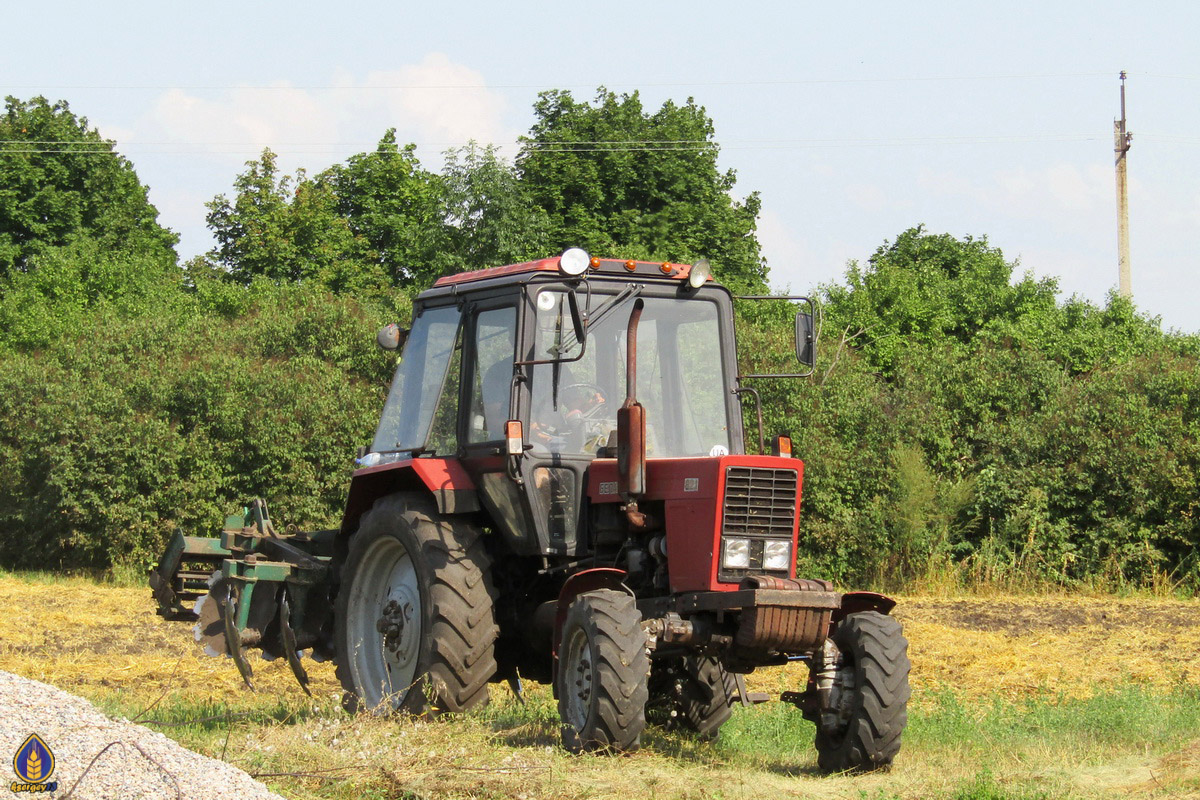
347;536;422;710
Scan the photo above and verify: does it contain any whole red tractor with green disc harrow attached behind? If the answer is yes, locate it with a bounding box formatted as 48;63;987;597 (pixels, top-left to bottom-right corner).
151;248;908;771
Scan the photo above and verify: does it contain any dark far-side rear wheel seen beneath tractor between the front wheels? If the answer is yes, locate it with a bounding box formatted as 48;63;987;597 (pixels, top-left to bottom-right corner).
648;656;738;739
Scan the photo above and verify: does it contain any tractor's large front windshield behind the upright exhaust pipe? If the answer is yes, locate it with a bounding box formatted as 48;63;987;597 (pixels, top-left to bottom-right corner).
529;289;730;458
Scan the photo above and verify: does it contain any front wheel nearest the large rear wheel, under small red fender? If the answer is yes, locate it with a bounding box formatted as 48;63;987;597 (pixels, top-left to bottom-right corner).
556;589;650;753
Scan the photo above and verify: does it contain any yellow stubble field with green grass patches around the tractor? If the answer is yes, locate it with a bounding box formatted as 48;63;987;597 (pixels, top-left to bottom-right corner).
0;575;1200;800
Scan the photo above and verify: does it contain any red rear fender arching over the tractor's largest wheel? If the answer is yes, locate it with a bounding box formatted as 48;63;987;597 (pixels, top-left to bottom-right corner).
341;458;479;536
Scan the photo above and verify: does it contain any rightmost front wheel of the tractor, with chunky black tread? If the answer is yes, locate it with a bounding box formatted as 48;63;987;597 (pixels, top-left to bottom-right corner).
816;612;910;772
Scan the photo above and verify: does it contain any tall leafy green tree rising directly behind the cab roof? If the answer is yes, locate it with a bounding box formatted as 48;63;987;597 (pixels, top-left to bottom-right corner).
517;89;767;289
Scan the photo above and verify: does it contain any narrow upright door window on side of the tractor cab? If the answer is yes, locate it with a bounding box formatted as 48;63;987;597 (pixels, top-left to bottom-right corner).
467;306;517;443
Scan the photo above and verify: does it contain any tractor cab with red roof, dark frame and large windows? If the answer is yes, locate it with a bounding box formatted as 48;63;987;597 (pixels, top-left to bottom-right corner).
364;251;743;557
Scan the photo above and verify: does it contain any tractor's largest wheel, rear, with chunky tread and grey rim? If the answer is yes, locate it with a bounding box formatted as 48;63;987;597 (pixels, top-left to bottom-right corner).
334;493;498;714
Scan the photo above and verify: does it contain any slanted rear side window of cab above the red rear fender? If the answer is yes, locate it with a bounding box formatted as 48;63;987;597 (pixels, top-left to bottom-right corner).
371;306;458;452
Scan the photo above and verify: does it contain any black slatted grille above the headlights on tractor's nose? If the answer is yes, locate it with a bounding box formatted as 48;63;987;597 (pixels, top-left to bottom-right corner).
721;467;797;539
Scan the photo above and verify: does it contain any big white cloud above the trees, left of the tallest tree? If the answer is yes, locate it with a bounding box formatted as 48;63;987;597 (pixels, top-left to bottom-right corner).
114;53;517;258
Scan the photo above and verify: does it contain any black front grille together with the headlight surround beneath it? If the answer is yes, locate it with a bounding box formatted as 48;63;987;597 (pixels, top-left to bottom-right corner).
718;467;798;582
